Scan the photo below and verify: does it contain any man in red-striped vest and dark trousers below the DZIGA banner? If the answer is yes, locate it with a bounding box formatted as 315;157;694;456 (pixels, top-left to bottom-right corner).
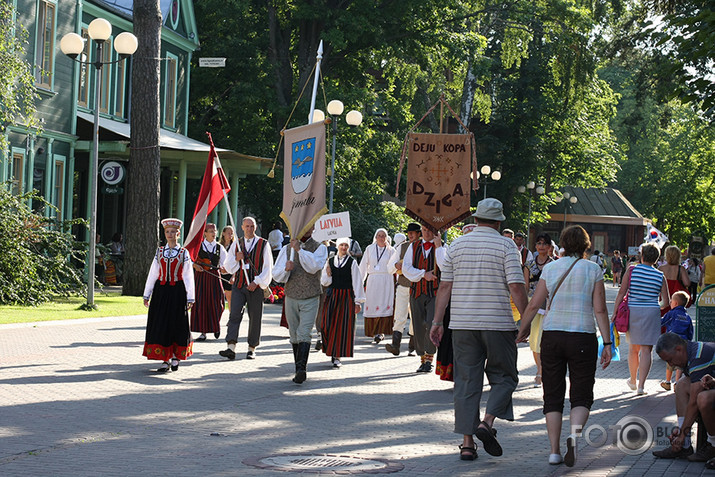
402;225;445;373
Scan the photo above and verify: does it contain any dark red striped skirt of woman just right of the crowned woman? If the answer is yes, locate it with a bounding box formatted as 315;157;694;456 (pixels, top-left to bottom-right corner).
191;270;226;333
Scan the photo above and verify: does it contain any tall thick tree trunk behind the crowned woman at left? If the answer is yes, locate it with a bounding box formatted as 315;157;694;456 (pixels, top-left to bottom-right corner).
122;0;161;296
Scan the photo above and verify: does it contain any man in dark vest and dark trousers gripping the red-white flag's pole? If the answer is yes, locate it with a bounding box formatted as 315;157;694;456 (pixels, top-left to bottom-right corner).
219;217;273;359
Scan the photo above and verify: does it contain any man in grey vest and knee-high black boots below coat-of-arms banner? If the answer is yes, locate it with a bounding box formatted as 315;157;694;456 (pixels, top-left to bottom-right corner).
273;226;328;384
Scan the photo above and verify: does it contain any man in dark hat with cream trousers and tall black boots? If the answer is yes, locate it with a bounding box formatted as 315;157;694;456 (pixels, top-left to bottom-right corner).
385;222;421;356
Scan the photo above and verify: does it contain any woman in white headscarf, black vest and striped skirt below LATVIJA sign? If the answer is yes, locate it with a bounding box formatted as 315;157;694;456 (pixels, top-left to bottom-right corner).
320;237;365;368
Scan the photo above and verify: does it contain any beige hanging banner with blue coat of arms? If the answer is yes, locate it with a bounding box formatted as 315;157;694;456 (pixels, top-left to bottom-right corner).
281;122;328;239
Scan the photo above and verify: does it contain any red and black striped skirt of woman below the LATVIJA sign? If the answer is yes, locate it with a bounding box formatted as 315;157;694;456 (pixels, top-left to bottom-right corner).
320;288;355;358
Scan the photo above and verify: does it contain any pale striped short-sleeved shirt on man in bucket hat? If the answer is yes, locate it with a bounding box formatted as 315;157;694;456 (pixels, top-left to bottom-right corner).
441;226;524;331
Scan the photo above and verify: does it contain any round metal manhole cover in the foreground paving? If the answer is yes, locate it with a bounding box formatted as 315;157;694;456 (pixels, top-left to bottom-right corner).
243;454;404;474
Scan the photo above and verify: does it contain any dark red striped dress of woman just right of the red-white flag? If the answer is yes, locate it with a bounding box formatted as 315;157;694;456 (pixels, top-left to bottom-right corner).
191;242;225;333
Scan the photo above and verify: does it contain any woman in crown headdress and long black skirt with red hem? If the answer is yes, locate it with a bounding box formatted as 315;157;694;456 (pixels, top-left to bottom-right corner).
142;219;194;373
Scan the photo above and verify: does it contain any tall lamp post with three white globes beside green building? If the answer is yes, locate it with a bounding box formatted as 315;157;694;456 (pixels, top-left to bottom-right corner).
60;18;138;308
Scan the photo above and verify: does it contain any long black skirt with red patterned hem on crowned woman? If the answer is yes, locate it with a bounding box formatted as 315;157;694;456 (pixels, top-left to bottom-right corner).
142;280;192;361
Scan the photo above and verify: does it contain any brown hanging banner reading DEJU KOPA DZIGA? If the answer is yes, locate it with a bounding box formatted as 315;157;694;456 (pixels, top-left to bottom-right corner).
405;133;473;232
